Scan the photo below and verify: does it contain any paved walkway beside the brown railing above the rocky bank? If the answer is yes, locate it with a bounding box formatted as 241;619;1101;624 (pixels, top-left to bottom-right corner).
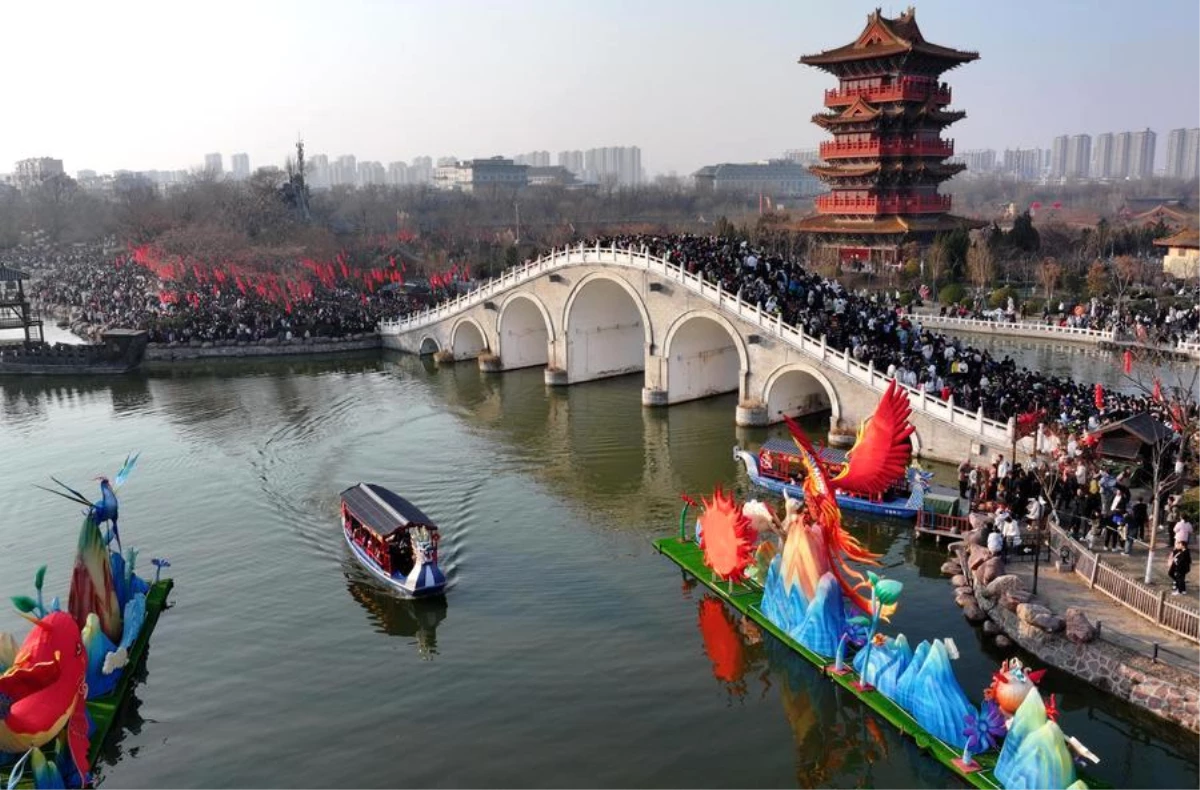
1006;546;1200;674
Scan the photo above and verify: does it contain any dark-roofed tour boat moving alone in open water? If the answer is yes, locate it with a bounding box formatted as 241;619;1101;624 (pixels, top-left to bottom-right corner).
342;483;446;598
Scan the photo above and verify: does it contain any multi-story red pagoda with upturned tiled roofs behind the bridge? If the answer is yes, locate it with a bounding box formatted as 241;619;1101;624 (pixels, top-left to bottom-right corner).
797;8;979;264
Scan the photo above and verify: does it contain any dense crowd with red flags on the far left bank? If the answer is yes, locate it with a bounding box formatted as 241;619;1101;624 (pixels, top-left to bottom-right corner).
6;245;419;343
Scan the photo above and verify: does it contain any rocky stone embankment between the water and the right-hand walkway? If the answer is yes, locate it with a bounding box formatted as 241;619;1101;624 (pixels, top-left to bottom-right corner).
942;529;1200;732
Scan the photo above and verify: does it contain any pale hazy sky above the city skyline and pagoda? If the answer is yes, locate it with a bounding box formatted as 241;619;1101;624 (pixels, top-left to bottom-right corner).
0;0;1200;174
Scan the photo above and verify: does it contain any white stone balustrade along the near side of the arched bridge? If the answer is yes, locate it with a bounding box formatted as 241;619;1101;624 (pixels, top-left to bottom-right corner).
379;245;1015;444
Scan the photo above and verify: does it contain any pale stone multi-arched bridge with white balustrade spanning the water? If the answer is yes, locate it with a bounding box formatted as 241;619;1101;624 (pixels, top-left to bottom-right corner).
379;246;1014;462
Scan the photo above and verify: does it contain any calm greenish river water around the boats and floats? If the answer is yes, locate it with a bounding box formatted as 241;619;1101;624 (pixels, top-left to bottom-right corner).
0;357;1200;790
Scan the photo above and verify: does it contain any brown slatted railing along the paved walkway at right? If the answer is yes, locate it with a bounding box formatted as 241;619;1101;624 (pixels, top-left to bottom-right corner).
1049;525;1200;644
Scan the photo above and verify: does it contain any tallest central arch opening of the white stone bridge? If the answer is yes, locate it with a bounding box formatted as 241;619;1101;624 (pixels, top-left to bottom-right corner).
562;271;654;384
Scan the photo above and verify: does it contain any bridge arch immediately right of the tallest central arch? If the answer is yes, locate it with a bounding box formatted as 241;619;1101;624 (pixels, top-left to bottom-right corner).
662;310;750;403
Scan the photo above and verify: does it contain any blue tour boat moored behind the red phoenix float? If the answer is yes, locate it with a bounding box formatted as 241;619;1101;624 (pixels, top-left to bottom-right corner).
733;438;929;519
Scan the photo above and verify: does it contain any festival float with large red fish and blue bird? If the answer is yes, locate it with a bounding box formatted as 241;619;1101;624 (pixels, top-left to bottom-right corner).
0;456;174;790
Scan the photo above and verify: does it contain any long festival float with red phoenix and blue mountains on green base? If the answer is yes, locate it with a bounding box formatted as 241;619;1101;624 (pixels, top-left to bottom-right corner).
655;382;1099;790
